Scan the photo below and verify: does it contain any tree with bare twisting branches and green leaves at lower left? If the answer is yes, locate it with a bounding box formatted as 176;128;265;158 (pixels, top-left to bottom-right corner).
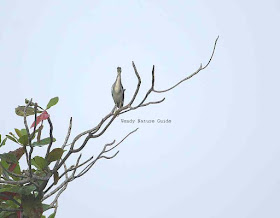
0;37;219;218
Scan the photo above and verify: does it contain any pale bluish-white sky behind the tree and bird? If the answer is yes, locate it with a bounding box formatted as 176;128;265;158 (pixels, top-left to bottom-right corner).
0;0;280;218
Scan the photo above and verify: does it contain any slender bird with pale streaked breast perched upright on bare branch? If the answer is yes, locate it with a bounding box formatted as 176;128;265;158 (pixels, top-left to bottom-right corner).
112;67;125;108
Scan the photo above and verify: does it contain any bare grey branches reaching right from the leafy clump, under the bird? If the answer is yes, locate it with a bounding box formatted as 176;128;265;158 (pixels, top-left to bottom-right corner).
44;37;219;206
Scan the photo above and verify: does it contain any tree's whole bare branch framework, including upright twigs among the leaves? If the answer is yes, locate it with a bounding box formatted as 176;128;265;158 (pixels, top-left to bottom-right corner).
0;37;219;215
